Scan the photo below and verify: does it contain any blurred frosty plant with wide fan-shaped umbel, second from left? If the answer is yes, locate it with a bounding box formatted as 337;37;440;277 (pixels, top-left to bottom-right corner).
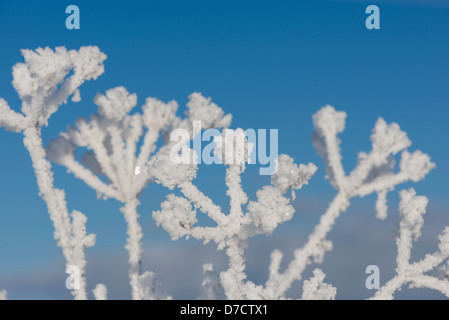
47;87;231;300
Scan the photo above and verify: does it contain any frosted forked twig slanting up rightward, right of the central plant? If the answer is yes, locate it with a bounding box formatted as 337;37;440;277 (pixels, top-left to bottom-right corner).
267;106;435;298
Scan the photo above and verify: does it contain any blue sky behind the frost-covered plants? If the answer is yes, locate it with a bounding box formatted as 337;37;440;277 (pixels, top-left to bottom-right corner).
0;0;449;298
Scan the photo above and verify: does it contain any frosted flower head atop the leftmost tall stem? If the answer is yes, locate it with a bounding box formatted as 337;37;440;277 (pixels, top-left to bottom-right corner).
12;46;106;125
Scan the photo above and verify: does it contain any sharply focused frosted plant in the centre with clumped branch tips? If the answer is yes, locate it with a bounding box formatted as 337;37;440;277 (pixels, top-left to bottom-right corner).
149;129;317;299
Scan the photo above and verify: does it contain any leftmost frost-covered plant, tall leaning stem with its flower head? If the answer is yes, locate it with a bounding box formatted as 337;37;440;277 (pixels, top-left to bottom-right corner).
0;47;106;299
